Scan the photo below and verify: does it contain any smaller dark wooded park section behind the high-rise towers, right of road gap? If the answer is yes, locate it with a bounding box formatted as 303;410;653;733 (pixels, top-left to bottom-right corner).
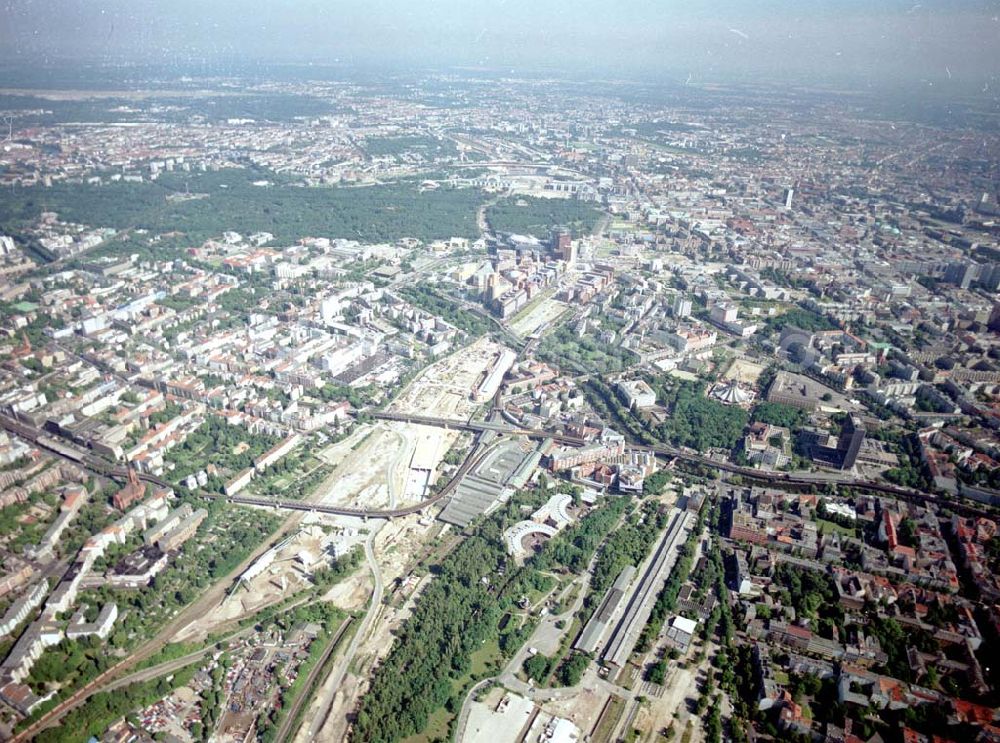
486;196;603;239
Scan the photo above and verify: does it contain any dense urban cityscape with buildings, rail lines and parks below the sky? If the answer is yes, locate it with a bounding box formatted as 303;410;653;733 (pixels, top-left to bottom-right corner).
0;13;1000;743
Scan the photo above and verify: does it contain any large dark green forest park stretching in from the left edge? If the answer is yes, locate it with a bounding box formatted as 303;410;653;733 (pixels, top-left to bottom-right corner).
0;169;482;244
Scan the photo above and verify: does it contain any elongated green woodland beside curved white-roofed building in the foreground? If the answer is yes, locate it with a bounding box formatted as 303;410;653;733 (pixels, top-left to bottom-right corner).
352;492;624;741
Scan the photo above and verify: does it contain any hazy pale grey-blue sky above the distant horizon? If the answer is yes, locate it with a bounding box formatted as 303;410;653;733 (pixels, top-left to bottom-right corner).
0;0;1000;93
